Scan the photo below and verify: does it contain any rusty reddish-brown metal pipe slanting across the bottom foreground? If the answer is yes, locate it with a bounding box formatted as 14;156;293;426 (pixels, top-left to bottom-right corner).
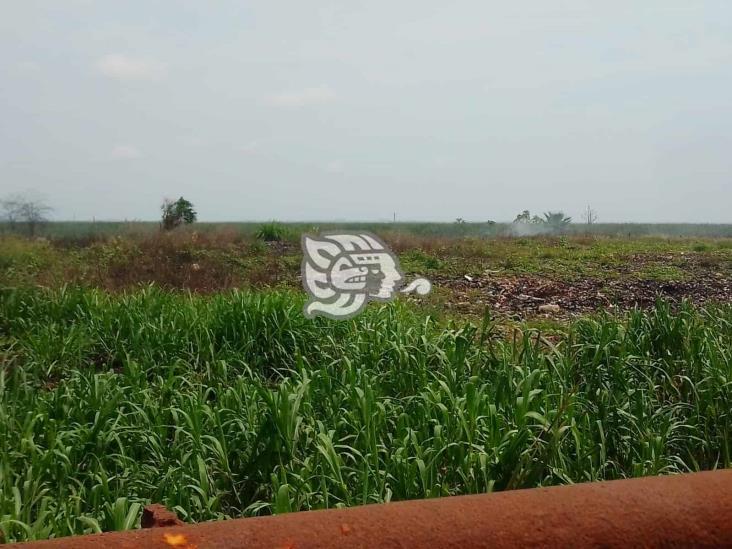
10;470;732;549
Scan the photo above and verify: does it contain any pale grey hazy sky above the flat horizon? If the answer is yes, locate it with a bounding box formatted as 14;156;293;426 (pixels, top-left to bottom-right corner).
0;0;732;223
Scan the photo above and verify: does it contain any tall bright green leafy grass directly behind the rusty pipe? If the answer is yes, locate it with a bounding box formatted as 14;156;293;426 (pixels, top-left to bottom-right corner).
0;286;732;540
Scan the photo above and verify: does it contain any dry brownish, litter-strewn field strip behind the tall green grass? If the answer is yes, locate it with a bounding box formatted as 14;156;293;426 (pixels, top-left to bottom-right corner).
0;226;732;320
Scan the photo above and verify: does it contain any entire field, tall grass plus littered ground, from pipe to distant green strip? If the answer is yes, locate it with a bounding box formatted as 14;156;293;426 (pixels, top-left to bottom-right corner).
0;226;732;541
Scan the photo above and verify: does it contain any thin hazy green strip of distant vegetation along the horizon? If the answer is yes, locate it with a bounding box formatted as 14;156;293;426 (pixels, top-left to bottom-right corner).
0;221;732;239
